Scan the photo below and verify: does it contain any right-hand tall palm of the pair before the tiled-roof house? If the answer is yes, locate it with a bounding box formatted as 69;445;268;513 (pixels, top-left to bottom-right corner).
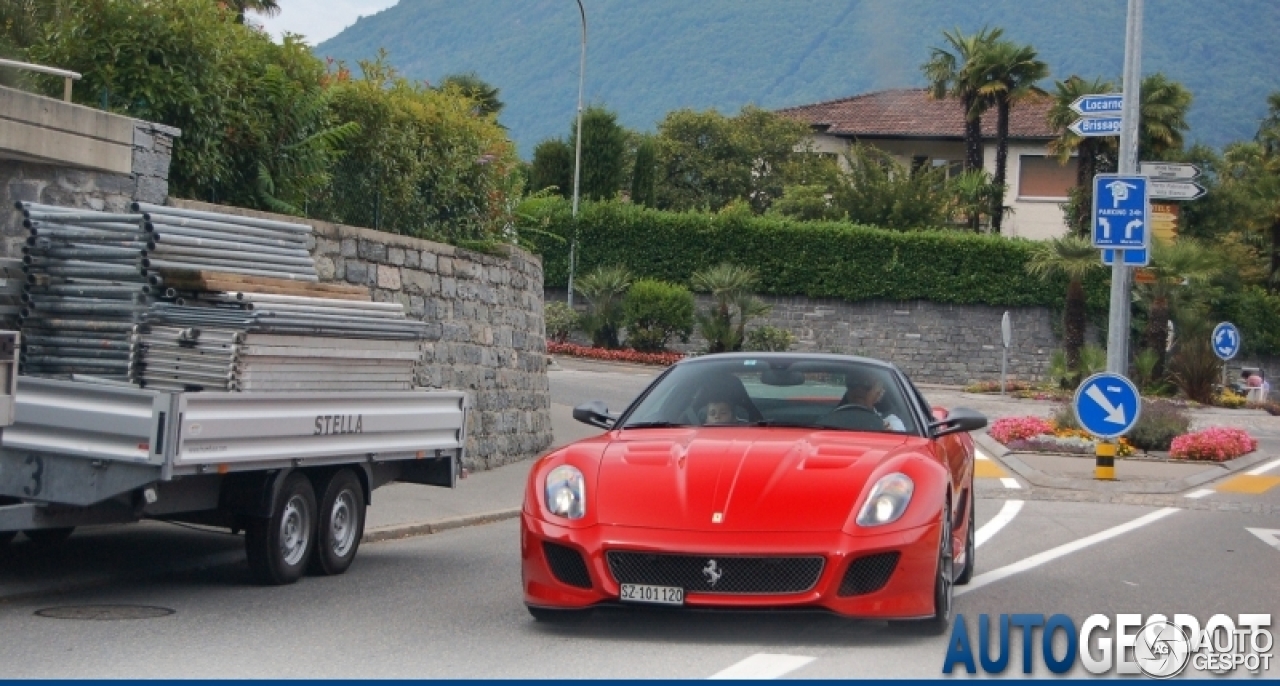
974;41;1048;233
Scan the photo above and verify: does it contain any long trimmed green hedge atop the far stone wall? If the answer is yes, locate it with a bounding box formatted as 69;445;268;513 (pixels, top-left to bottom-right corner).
520;198;1107;308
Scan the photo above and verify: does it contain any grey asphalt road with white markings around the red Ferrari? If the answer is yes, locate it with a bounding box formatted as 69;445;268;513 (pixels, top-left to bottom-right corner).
0;365;1280;678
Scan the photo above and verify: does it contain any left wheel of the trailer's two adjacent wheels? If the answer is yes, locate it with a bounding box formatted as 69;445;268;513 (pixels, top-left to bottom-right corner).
244;472;316;586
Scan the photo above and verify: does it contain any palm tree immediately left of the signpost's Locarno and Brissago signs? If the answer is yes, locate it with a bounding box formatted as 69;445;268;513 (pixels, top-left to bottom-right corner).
1048;74;1117;235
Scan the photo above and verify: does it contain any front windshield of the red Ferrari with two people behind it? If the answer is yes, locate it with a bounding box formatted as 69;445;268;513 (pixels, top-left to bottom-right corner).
622;357;916;433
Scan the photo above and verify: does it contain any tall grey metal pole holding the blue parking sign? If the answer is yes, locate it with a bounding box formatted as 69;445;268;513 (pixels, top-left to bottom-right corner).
1107;0;1143;375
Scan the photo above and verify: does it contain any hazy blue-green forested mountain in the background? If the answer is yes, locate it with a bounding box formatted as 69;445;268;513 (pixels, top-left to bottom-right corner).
316;0;1280;157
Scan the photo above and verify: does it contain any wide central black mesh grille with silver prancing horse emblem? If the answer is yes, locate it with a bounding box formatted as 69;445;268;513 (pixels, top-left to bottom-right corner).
605;550;823;595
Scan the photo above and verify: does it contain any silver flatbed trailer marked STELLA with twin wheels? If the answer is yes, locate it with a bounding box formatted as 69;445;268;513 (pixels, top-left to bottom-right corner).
0;360;470;585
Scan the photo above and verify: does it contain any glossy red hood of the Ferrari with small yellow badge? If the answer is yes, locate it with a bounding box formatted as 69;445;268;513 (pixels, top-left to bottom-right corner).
594;427;911;531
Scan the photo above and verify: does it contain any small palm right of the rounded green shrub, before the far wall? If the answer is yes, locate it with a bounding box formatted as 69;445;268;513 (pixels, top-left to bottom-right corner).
690;262;769;352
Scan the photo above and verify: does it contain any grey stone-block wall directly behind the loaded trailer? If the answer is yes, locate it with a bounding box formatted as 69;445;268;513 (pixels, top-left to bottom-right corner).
169;200;552;470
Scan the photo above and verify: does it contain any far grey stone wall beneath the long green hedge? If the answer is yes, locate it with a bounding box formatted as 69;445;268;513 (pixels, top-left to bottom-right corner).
545;291;1060;385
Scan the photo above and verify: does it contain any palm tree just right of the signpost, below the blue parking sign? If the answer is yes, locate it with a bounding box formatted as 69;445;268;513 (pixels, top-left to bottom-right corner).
1139;238;1221;379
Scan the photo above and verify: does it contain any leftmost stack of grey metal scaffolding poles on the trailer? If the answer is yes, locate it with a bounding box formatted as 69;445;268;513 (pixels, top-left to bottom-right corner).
17;202;151;380
